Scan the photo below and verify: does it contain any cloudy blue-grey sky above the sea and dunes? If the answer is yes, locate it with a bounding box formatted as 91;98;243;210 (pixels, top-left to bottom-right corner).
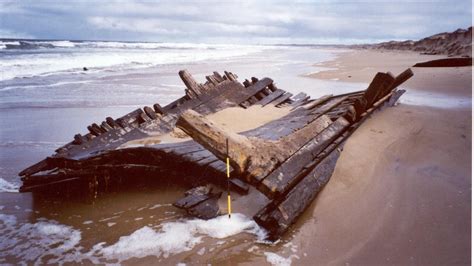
0;0;472;44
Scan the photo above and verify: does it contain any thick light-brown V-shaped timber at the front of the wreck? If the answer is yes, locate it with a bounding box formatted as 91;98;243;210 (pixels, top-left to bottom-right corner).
176;110;336;183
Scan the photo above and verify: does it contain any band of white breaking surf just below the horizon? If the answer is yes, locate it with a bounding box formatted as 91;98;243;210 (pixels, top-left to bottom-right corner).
0;40;270;80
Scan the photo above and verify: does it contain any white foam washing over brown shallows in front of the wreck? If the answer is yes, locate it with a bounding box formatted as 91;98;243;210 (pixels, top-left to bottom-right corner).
0;213;266;264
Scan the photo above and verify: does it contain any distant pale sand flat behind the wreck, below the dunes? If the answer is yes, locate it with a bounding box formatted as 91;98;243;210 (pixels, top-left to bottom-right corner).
305;49;472;97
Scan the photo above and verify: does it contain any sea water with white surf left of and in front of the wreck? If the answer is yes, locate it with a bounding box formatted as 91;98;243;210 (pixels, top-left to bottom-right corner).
0;40;366;265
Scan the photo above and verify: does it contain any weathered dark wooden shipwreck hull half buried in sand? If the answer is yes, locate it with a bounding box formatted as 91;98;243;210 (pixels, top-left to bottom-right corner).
19;69;413;239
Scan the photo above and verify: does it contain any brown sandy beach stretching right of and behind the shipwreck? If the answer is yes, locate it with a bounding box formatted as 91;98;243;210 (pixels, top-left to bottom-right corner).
268;50;472;265
